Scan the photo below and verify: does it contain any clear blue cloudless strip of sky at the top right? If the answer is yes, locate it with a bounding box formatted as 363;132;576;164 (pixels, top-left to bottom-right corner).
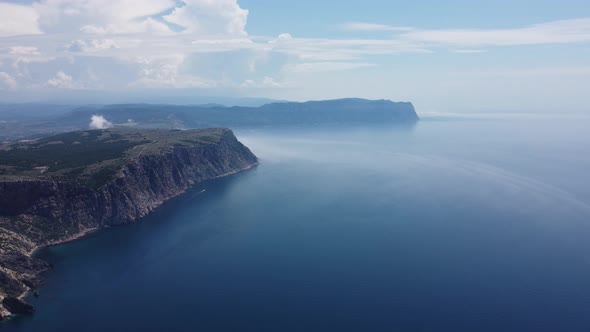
239;0;590;33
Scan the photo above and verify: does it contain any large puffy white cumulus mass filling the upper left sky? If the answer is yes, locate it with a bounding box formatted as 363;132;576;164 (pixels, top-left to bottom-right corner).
0;0;264;89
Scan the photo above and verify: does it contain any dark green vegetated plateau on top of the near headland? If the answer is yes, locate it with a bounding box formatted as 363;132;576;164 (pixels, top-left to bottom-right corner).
0;129;227;187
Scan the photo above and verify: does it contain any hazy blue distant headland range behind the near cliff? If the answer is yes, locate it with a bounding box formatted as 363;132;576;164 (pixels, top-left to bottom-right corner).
0;98;418;140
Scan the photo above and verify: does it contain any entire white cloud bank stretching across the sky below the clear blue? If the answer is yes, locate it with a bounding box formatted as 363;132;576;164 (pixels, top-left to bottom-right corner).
0;0;590;109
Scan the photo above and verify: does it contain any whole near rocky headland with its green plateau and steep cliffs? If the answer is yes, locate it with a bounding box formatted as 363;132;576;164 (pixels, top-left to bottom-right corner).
0;129;257;316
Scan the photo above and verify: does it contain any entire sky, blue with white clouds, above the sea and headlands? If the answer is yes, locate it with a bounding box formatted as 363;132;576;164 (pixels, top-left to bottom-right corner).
0;0;590;113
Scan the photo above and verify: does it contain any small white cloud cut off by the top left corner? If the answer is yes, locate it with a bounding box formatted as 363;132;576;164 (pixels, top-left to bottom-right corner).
0;3;41;37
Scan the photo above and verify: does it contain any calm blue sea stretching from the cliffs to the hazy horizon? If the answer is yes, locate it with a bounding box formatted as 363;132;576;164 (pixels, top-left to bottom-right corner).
1;119;590;332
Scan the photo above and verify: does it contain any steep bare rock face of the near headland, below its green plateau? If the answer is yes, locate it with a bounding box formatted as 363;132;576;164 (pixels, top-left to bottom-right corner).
0;130;257;316
